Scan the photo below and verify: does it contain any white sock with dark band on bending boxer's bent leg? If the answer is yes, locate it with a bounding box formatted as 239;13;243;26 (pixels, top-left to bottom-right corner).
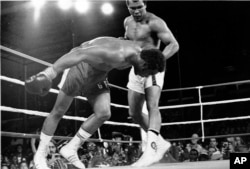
67;128;91;150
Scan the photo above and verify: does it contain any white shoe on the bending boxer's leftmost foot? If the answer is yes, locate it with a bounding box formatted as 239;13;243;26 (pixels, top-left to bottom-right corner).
34;151;50;169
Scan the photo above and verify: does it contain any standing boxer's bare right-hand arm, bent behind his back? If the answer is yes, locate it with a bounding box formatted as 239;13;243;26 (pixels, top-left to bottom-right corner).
151;18;179;59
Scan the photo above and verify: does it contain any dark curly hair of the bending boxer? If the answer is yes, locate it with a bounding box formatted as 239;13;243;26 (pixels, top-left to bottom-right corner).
140;49;166;72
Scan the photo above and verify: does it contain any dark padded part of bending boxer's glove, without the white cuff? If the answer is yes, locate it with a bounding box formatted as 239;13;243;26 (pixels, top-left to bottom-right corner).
25;73;52;96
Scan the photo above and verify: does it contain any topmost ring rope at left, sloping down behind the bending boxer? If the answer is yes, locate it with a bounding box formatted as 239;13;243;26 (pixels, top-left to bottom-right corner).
0;45;127;91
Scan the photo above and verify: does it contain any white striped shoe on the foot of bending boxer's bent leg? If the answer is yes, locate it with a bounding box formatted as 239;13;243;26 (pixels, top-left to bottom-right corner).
59;145;85;169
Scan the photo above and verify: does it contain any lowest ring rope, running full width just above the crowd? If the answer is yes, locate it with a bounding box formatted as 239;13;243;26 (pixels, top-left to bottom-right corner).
1;131;250;143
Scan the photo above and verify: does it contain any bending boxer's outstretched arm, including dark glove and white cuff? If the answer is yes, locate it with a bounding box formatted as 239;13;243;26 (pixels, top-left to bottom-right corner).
25;46;113;96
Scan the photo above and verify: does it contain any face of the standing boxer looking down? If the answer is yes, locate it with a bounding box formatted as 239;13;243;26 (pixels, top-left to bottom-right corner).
128;0;146;22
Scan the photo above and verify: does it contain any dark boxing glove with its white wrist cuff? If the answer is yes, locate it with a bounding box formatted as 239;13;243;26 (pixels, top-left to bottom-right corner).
25;67;56;96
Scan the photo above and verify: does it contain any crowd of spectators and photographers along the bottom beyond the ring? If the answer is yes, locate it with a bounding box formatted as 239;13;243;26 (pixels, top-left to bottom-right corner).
1;132;250;169
